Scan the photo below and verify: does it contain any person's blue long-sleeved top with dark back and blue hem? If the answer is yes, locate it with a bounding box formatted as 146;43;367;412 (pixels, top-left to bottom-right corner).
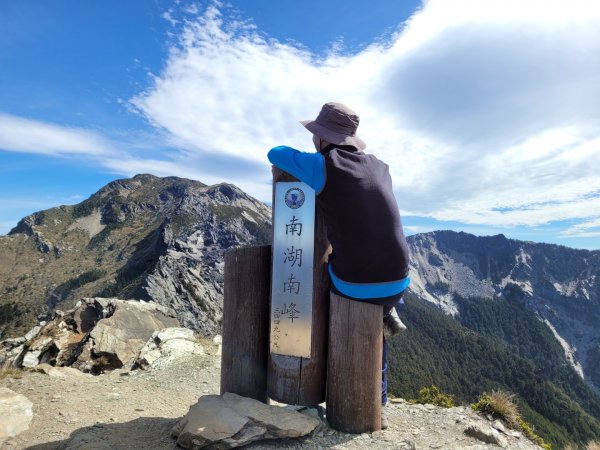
268;146;410;301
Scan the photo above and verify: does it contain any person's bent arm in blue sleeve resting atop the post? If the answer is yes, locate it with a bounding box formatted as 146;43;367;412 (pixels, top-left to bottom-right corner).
267;145;325;194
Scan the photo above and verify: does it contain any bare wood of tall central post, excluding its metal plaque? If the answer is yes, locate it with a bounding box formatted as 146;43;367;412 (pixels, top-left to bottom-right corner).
267;167;331;406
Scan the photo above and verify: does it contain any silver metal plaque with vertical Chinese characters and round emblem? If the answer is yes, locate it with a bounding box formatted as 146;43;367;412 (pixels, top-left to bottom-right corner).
270;181;315;358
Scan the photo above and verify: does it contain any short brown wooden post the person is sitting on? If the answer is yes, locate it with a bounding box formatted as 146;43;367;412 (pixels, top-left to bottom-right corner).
327;293;383;433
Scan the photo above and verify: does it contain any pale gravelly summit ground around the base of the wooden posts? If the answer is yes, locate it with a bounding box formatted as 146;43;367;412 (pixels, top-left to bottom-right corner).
0;341;538;450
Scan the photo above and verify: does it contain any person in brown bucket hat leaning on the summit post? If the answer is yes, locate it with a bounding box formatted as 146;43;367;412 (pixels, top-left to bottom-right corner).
268;102;410;428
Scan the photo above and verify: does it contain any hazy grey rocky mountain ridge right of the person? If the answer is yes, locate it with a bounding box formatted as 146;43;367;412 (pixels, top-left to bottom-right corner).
408;231;600;392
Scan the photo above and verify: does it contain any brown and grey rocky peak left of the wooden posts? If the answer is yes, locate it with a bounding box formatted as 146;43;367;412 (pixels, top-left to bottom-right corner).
0;175;271;336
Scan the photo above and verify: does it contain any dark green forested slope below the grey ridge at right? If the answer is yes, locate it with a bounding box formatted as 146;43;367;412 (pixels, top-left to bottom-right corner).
389;293;600;448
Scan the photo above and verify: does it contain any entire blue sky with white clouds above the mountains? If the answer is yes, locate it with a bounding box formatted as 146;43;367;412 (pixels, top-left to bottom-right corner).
0;0;600;249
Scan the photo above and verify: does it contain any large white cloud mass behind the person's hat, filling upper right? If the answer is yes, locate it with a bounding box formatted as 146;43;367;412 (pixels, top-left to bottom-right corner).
132;0;600;232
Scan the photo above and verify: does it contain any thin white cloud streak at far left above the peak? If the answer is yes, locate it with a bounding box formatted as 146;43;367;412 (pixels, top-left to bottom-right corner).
0;113;114;156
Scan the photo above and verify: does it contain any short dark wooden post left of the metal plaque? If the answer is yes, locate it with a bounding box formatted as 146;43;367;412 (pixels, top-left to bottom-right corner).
221;245;271;403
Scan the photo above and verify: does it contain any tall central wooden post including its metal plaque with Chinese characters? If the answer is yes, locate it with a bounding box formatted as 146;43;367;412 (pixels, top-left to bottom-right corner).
267;167;330;406
